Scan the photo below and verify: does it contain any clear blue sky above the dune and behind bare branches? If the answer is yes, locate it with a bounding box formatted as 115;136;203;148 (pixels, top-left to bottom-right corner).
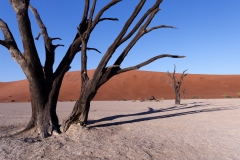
0;0;240;82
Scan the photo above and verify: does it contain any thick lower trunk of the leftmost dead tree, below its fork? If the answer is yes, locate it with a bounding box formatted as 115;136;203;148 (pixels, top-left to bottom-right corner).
23;78;60;138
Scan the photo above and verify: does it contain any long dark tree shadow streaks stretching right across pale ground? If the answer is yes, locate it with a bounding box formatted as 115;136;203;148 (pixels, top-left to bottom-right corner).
88;104;240;128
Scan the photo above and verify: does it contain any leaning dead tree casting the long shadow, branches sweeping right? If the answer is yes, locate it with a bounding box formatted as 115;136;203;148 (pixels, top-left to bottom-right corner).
61;0;184;132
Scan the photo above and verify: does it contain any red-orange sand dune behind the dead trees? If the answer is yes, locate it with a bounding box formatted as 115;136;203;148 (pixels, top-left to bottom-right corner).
0;70;240;102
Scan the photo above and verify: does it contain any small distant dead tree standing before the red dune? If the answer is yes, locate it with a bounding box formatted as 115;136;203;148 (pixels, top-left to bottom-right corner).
162;65;188;104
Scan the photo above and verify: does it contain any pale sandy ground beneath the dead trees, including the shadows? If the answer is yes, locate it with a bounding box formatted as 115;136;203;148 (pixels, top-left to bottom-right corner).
0;99;240;160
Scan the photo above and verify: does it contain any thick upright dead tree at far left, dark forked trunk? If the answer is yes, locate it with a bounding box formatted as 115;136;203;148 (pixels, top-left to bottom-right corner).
0;0;100;137
